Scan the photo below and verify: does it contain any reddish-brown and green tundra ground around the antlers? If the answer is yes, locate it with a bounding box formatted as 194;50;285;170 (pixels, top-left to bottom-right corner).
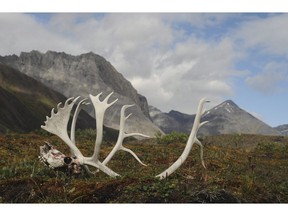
0;132;288;203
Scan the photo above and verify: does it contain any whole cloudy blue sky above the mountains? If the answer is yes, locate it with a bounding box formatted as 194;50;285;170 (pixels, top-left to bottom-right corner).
0;7;288;126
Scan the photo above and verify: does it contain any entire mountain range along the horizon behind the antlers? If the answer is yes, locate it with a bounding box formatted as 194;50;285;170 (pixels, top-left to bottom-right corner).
0;51;288;136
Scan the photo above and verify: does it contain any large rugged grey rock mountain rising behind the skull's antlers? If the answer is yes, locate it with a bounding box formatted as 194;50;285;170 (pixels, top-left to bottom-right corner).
0;51;160;136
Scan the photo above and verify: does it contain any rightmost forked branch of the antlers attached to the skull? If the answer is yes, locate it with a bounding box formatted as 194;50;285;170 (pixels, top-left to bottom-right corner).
103;104;149;166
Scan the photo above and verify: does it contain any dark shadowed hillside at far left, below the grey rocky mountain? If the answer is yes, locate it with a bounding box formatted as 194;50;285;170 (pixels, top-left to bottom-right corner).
0;63;95;133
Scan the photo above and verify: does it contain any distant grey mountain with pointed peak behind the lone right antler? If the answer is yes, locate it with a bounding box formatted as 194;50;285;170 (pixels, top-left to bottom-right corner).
150;100;281;135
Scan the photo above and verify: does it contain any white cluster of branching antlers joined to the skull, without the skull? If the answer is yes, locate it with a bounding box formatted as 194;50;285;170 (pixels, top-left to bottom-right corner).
41;92;149;177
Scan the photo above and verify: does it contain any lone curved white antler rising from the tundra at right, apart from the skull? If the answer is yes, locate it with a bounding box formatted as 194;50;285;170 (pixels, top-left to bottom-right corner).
156;98;209;179
